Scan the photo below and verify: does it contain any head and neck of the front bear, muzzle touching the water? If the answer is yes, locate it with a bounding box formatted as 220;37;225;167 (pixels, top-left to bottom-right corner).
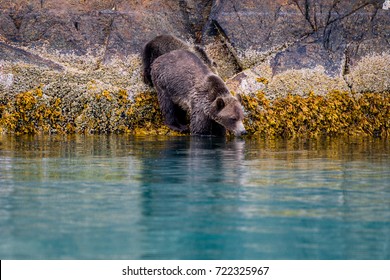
207;75;246;136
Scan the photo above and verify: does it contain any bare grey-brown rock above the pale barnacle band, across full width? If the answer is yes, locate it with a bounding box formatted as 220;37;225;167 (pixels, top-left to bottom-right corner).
0;0;390;90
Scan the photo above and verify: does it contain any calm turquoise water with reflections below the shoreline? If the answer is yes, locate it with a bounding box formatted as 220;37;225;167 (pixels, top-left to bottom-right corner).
0;136;390;259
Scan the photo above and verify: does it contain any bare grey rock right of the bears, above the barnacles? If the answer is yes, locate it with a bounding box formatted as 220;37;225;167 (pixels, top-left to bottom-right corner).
204;0;390;76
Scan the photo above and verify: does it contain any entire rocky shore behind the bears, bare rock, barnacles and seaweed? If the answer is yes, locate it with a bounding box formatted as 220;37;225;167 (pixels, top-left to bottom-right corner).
0;0;390;137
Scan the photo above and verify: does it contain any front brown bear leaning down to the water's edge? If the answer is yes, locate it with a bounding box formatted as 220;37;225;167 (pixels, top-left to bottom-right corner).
151;50;246;136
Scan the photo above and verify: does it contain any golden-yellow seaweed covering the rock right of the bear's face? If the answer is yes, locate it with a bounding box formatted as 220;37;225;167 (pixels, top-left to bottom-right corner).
242;91;390;138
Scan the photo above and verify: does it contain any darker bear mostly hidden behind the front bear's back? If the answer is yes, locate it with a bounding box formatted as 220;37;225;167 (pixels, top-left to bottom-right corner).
142;35;217;85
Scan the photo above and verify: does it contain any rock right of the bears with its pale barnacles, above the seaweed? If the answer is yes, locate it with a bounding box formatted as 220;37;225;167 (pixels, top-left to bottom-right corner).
204;0;390;96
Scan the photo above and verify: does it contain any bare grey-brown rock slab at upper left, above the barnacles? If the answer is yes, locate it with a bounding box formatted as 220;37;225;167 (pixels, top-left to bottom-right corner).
0;0;211;63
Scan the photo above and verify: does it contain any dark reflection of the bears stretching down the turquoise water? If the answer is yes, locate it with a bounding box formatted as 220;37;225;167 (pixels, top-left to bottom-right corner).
139;137;245;259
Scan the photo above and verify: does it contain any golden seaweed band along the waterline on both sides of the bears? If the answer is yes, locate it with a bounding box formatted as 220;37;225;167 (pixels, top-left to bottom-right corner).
0;85;390;138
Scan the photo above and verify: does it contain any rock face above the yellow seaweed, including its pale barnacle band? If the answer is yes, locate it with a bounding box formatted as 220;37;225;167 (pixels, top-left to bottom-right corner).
0;0;390;136
